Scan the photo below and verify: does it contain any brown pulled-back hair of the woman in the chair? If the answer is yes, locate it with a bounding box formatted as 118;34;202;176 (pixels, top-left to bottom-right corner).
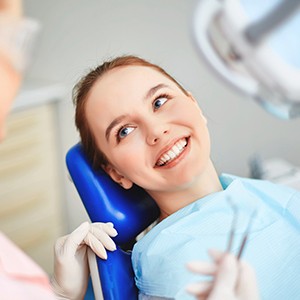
73;55;187;169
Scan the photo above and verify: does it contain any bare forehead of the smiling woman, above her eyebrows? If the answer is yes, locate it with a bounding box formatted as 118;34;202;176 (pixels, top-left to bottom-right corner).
85;66;179;129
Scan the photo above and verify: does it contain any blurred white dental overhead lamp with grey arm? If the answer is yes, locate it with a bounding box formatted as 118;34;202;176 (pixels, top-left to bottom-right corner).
194;0;300;119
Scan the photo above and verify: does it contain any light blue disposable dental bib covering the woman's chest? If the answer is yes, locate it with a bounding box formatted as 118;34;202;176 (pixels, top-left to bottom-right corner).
132;175;300;300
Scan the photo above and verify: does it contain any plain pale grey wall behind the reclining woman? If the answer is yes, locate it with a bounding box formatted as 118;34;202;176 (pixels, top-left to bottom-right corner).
25;0;300;228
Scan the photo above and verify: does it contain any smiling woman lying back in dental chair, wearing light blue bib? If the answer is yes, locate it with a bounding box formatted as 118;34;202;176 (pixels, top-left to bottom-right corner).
74;56;300;299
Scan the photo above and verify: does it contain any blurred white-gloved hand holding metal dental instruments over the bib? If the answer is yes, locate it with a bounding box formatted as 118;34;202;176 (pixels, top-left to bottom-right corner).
187;250;259;300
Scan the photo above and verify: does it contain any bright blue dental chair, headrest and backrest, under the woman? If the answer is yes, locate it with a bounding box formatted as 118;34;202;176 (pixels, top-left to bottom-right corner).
66;144;159;300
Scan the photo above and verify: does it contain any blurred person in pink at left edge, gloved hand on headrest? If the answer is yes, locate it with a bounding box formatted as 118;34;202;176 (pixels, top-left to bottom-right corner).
0;0;117;300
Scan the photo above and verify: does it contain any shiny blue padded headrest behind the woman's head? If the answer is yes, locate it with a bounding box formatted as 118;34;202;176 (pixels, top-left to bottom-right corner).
66;144;159;244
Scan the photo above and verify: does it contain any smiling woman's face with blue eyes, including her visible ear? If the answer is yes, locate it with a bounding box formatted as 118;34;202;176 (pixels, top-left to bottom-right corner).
86;66;210;199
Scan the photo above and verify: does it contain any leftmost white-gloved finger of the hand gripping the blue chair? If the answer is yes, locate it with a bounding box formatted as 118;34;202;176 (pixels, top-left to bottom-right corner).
62;222;90;256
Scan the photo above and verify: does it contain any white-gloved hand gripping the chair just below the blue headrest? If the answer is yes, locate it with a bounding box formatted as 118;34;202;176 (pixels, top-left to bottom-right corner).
51;222;117;300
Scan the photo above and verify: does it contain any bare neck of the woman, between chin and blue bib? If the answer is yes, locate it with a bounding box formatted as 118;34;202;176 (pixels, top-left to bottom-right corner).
153;161;223;220
